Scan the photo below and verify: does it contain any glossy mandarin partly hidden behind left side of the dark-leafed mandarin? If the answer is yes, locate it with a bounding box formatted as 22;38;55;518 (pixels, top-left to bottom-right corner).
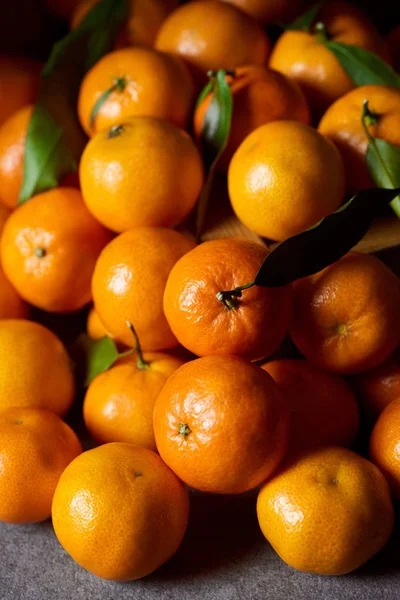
92;227;196;351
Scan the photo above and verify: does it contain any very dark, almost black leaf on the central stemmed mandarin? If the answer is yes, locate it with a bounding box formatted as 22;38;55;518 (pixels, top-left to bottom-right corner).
255;188;400;287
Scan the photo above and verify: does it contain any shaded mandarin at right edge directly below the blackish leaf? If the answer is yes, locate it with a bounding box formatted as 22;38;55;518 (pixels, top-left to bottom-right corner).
289;252;400;374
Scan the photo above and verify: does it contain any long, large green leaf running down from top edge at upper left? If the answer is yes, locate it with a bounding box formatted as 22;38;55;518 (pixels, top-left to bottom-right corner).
19;0;128;203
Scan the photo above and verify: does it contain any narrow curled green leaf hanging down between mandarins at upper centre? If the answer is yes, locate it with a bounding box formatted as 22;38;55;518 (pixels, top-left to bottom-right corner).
196;69;233;239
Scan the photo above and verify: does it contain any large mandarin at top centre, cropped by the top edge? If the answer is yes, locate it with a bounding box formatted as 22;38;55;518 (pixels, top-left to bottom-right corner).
155;0;270;78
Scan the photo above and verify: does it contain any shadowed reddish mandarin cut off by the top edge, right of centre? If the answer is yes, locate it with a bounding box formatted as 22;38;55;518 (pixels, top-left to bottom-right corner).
217;0;307;23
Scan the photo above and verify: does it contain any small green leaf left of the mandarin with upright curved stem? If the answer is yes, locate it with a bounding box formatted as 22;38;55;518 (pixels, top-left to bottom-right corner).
76;333;121;387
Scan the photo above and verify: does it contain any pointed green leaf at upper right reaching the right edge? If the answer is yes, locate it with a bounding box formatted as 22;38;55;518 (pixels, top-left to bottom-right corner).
325;40;400;87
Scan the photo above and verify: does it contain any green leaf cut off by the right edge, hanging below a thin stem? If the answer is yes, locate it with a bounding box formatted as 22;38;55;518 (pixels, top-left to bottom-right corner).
366;139;400;217
